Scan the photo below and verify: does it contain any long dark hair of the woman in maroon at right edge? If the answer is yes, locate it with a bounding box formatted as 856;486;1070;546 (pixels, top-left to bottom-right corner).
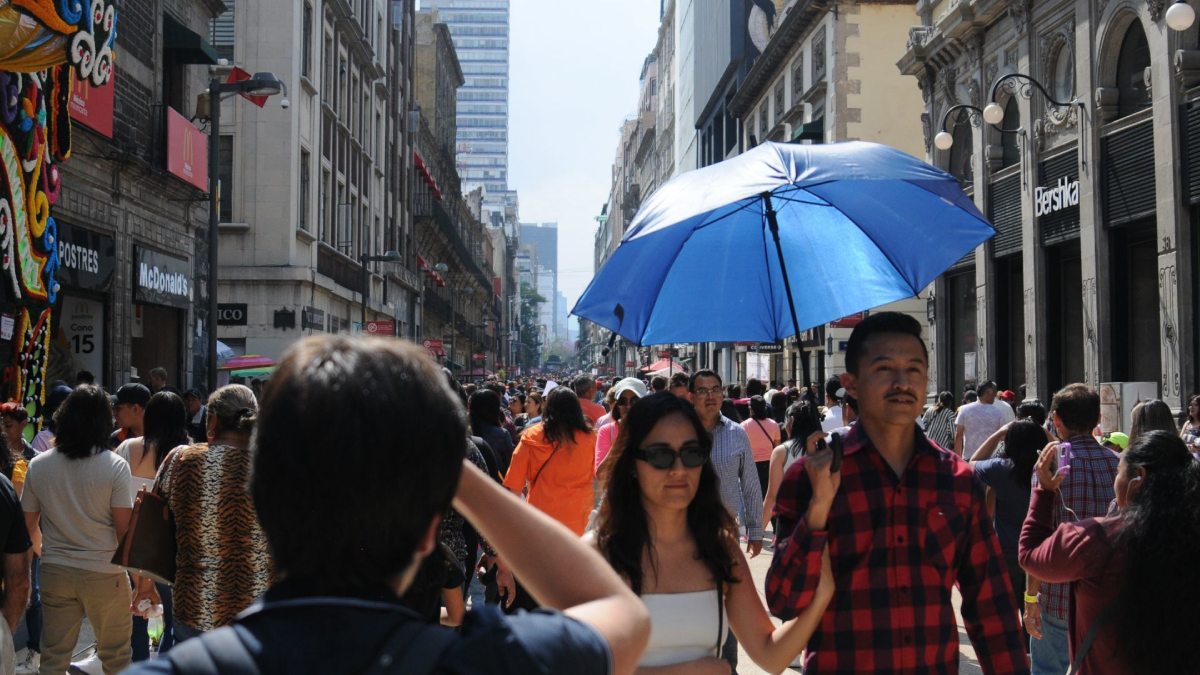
1116;431;1200;673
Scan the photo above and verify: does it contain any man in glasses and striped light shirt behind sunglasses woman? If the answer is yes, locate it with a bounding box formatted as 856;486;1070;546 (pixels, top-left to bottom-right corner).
688;370;762;673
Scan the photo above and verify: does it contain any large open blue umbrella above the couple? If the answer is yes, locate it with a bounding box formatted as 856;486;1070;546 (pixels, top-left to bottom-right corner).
571;142;995;379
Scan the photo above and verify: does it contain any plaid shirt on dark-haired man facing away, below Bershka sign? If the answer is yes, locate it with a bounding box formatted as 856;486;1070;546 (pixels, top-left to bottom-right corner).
1033;434;1121;621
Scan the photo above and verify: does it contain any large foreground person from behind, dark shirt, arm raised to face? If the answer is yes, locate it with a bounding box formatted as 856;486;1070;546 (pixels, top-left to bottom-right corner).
131;336;649;675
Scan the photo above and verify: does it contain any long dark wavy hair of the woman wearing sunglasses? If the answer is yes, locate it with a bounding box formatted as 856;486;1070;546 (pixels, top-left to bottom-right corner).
596;392;738;595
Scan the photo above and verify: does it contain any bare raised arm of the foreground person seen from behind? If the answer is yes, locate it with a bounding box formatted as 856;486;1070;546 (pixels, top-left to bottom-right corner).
454;461;650;673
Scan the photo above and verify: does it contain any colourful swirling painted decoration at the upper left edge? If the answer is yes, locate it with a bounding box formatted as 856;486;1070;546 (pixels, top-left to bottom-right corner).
0;0;116;429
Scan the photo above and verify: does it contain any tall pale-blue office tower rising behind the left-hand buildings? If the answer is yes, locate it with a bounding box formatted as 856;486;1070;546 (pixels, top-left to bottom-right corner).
422;0;509;218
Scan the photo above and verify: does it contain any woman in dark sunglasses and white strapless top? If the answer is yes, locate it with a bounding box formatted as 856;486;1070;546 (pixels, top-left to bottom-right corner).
588;393;833;674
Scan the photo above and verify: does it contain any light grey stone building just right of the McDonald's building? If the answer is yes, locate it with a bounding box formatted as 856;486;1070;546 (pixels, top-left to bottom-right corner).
214;0;421;358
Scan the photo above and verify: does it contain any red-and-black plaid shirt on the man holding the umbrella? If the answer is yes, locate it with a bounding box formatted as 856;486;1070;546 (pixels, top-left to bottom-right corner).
767;426;1030;675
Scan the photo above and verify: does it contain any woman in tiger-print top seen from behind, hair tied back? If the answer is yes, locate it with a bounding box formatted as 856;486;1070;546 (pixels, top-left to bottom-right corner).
133;384;270;646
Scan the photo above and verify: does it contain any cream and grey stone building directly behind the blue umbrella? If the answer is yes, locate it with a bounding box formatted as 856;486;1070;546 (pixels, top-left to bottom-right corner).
725;0;928;382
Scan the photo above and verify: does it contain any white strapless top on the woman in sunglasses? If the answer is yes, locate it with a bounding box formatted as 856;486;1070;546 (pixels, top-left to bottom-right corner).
638;589;730;667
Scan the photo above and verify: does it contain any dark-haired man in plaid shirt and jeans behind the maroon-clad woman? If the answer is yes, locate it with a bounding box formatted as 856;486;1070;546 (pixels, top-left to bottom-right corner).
1021;383;1121;673
